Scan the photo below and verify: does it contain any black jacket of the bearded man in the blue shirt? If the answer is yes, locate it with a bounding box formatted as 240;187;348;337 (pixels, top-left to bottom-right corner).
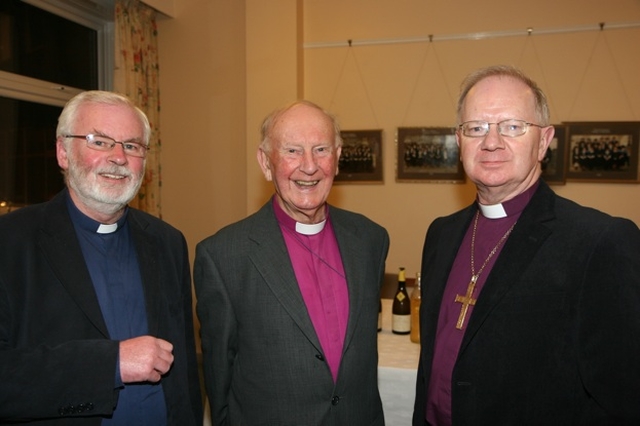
0;191;202;426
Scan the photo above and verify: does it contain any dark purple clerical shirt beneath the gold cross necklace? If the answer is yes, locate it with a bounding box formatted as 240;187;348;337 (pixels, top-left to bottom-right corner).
426;184;538;426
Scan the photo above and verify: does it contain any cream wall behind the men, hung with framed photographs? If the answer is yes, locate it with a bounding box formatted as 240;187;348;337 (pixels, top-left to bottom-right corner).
158;0;640;275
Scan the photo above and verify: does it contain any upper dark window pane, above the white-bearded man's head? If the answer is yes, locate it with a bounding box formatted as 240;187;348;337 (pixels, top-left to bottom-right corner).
0;0;98;90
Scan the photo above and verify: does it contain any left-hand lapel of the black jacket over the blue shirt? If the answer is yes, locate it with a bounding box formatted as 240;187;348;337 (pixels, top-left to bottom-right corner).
38;192;109;338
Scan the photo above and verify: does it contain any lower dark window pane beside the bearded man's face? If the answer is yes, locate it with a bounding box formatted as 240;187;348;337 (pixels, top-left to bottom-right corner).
0;96;64;206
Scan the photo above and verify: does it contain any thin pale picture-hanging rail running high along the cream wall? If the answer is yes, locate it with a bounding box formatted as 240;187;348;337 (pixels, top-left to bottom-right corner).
303;22;640;49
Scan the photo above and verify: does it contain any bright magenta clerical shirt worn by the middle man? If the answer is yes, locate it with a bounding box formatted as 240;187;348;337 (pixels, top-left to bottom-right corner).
273;200;349;382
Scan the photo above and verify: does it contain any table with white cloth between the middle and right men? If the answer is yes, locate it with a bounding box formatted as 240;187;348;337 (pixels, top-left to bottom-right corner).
378;299;420;426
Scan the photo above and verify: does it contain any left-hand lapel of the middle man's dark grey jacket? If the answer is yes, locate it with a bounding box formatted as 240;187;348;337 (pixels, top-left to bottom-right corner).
248;202;322;351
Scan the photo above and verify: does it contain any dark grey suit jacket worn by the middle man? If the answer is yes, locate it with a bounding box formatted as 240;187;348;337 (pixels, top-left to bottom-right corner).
194;202;389;426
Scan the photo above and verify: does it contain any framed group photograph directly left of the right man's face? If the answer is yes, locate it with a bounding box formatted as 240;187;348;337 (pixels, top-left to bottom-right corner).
396;127;465;183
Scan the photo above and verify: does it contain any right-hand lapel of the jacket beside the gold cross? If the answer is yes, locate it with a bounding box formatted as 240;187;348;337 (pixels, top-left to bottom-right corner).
460;182;554;353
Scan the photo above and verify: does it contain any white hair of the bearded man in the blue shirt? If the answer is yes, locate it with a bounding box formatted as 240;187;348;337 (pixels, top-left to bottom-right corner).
56;90;151;145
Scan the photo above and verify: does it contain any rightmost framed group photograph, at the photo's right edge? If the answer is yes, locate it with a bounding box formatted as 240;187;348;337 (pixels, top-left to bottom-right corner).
564;121;640;183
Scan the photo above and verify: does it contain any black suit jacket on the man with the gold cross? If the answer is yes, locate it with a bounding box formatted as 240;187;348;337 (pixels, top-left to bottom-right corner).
414;182;640;426
